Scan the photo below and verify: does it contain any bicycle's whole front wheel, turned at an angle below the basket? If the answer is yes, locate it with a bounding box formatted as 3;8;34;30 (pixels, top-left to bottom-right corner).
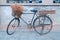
6;18;20;35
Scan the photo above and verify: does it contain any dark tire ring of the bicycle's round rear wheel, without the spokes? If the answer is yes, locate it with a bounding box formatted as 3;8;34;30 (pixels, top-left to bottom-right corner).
33;16;53;35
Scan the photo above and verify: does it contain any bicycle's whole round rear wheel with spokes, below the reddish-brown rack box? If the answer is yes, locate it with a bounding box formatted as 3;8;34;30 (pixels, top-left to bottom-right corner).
33;16;52;35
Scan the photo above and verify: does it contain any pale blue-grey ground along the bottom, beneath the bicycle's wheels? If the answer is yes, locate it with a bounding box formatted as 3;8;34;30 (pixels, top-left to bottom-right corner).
0;31;60;40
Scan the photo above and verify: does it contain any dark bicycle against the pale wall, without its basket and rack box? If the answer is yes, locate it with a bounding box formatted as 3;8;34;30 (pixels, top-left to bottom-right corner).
6;10;53;35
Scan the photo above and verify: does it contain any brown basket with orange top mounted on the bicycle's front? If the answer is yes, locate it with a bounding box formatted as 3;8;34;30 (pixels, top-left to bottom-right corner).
11;4;23;17
